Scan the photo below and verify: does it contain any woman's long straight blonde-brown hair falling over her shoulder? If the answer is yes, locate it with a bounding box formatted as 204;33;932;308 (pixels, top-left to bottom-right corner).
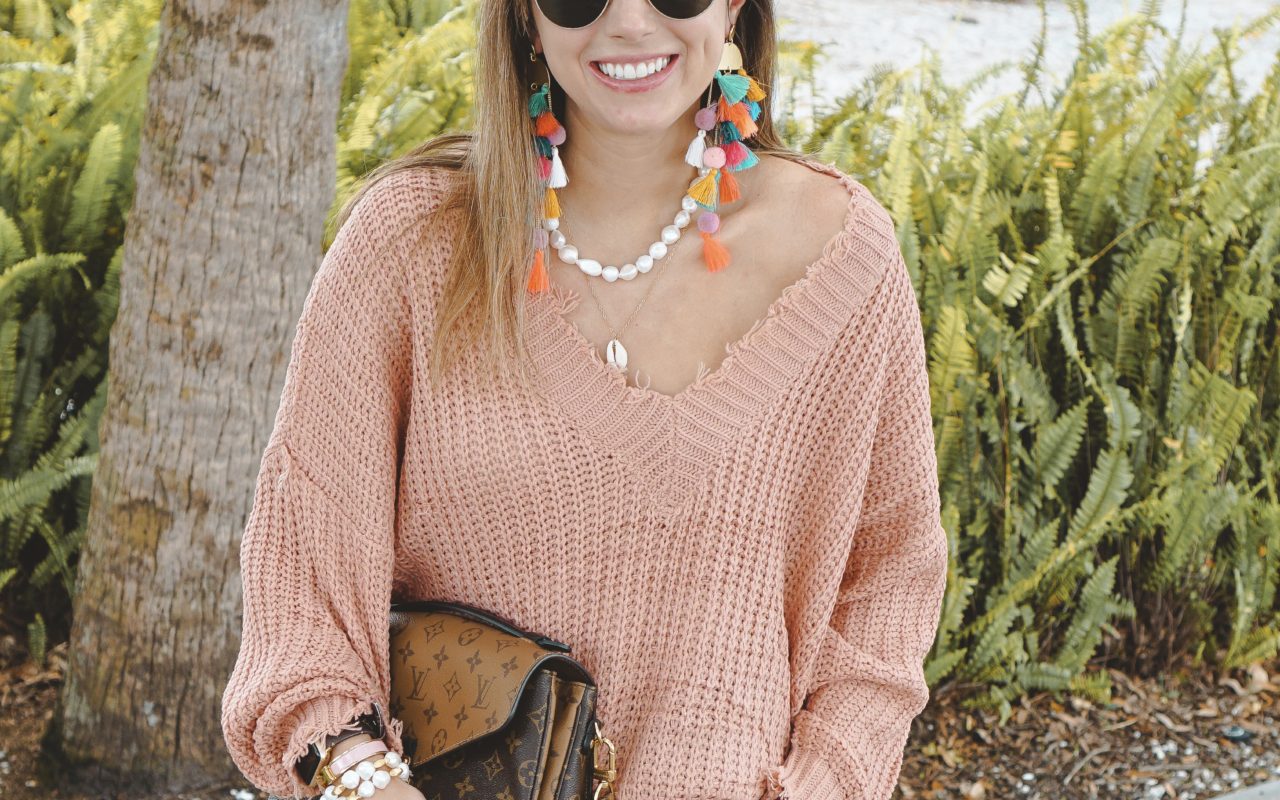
337;0;800;385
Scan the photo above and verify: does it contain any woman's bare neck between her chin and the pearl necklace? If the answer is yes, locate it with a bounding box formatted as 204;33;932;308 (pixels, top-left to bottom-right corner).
557;105;698;218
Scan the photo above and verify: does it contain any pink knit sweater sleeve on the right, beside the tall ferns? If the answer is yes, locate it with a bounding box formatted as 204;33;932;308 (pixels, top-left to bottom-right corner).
772;252;947;800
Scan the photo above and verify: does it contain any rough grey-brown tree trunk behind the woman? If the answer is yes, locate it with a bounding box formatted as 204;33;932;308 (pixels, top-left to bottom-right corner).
58;0;347;791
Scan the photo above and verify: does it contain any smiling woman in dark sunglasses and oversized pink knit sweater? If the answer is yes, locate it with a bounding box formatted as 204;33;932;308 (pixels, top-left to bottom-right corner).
223;0;947;800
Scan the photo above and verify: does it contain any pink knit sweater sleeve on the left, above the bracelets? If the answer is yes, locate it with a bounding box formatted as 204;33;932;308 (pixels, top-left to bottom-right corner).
221;179;411;797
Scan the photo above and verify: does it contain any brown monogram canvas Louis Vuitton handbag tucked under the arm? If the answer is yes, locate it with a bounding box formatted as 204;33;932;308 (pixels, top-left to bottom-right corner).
389;600;617;800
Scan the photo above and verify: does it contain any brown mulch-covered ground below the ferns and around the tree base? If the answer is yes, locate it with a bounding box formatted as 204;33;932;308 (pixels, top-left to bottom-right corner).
0;636;1280;800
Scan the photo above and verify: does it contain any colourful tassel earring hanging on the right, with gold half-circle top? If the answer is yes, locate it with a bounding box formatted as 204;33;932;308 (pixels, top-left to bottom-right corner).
685;26;765;273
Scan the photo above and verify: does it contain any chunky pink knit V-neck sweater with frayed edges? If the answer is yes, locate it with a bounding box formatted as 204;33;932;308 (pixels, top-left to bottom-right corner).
221;157;947;800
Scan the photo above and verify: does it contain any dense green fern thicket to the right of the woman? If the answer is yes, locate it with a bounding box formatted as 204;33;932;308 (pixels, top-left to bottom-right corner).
808;1;1280;716
